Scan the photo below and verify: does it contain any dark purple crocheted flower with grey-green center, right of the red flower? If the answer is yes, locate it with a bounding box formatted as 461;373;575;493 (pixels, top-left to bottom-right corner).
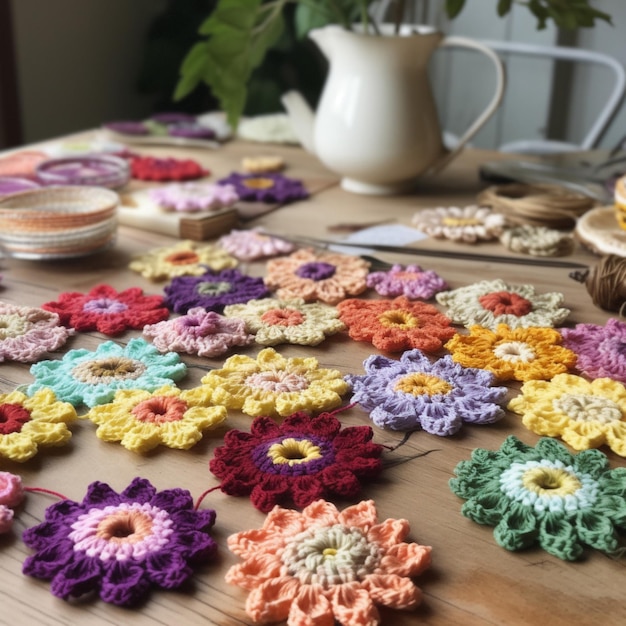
164;270;269;313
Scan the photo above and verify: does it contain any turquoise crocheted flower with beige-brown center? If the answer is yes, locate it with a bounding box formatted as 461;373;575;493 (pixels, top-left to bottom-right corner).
28;338;187;407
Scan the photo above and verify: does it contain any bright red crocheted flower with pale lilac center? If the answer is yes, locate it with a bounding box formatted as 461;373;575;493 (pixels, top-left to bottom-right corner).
41;285;170;335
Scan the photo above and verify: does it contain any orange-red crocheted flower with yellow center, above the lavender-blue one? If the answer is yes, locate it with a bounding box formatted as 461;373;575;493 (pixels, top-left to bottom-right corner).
337;296;456;352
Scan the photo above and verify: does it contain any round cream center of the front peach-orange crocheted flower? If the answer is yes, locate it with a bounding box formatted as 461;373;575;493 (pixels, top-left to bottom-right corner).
282;524;381;589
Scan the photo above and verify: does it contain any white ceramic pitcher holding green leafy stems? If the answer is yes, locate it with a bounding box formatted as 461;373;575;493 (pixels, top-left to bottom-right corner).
282;24;504;194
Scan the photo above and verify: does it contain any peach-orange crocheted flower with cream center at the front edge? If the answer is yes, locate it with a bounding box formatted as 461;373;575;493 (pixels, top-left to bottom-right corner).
226;500;431;626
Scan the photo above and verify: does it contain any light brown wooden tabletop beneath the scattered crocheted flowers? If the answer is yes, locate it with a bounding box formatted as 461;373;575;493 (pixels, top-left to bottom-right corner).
0;134;626;626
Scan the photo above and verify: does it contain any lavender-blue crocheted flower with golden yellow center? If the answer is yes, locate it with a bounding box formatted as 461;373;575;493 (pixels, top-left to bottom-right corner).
346;350;507;435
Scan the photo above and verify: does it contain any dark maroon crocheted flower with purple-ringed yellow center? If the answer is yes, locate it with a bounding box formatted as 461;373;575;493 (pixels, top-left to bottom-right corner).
209;412;383;512
